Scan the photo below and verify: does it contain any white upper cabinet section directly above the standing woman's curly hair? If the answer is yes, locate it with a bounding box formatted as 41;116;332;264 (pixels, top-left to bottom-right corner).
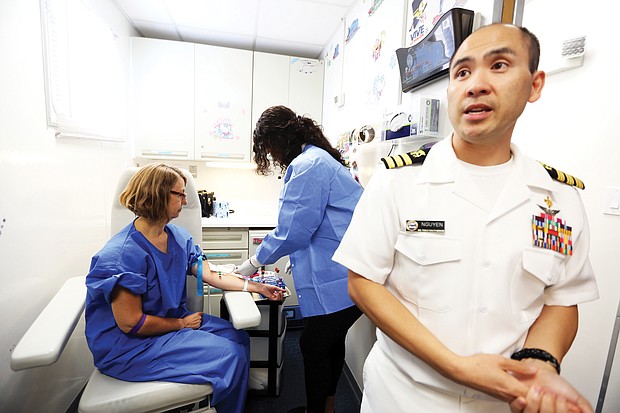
252;52;323;130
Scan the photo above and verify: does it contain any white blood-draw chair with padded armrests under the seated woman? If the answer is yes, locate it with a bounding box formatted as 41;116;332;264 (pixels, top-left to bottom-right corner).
11;168;261;413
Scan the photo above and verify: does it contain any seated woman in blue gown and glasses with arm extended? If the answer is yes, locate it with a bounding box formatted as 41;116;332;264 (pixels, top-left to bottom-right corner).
86;164;282;413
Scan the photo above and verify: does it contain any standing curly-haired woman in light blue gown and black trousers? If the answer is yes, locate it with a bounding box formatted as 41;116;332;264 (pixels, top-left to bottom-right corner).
236;106;362;413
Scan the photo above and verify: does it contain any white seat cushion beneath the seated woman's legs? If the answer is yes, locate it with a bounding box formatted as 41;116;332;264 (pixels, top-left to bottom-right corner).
78;369;213;413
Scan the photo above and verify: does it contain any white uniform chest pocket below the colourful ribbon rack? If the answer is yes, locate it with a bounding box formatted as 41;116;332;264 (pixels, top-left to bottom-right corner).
510;247;566;322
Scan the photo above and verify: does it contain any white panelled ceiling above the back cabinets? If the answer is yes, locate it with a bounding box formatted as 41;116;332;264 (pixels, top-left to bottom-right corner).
113;0;356;58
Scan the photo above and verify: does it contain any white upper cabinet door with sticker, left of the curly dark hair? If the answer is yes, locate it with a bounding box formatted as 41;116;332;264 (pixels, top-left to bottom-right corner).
194;44;252;162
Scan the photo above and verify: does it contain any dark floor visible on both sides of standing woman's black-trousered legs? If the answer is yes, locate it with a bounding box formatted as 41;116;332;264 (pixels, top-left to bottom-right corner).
244;328;361;413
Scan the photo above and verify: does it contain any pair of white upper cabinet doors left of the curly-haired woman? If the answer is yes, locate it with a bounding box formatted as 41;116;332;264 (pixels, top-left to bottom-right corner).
132;37;253;161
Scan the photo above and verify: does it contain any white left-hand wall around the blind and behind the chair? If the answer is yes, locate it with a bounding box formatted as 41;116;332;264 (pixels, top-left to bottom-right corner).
0;0;137;412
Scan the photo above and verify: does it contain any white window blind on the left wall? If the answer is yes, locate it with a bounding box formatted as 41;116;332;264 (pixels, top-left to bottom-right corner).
41;0;127;141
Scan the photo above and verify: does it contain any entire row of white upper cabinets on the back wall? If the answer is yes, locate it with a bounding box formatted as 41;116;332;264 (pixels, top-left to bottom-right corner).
131;37;323;162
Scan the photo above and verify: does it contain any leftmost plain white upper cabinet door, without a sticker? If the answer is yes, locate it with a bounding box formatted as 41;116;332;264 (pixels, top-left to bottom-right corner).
131;37;194;159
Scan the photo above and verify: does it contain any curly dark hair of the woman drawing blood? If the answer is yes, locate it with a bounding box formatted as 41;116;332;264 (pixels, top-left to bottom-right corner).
252;106;345;175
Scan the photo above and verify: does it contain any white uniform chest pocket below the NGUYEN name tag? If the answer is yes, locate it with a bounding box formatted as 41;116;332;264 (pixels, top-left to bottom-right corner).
392;233;462;312
